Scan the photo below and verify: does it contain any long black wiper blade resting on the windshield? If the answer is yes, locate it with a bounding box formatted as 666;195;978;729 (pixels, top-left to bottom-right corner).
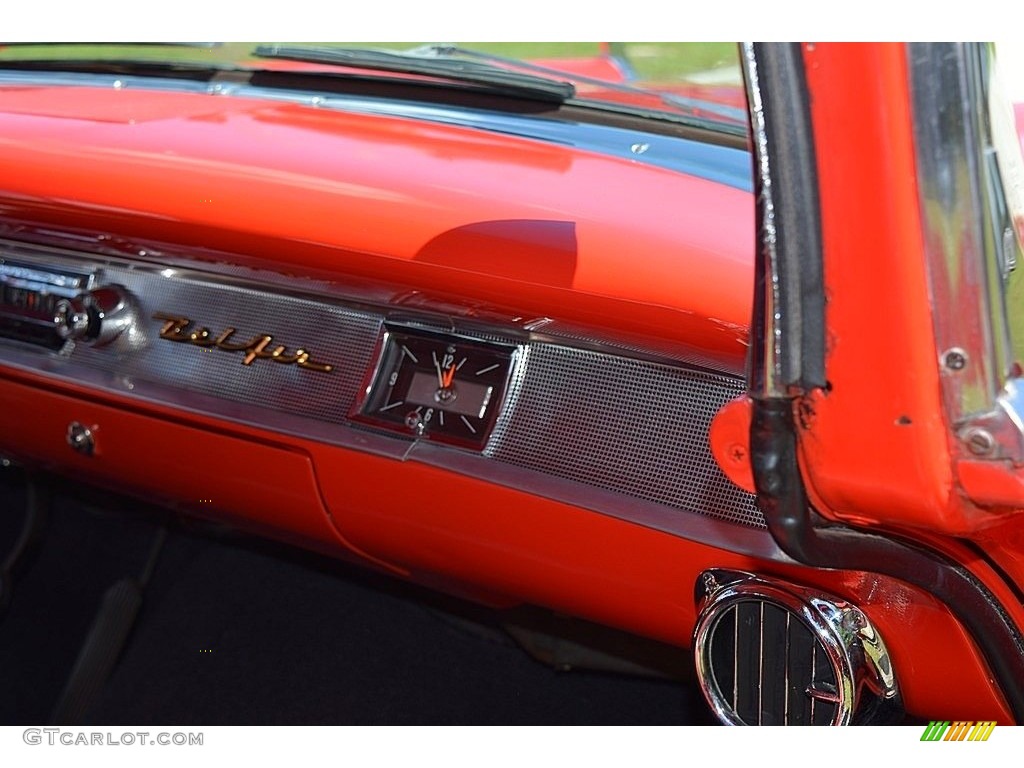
253;45;575;103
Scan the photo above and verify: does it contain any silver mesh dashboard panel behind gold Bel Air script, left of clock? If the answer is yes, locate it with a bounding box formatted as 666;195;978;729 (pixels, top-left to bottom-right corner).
70;267;383;424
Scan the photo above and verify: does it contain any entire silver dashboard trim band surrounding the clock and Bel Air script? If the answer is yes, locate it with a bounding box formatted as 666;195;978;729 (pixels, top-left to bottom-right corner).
0;243;765;540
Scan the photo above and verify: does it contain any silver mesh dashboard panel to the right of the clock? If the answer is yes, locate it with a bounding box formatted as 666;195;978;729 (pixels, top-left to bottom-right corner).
486;344;765;527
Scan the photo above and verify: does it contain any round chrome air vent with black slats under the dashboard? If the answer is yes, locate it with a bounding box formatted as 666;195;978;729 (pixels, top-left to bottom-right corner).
693;569;903;725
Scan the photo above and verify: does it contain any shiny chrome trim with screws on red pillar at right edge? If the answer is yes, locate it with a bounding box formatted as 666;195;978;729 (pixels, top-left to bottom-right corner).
907;43;1024;462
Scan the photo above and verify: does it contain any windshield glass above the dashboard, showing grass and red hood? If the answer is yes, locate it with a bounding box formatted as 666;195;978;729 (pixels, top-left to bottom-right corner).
0;42;746;135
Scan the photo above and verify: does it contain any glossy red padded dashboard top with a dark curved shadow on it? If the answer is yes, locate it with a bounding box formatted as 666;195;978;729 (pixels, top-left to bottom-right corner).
0;87;754;364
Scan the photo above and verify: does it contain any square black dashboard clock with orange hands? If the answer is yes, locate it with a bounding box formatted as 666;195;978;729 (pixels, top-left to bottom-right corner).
354;327;516;451
